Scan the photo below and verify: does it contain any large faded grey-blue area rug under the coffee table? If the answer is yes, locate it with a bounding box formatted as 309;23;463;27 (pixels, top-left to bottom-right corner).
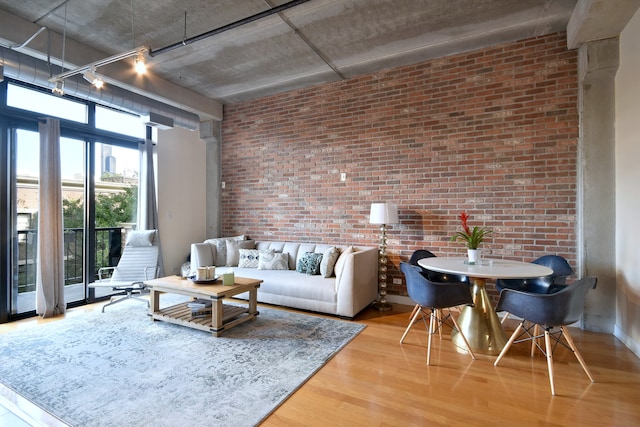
0;302;365;427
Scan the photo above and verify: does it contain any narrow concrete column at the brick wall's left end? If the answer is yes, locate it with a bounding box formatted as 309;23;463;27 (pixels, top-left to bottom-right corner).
200;120;222;239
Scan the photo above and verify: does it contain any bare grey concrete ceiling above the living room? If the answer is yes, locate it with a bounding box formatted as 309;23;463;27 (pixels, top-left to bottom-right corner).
0;0;576;108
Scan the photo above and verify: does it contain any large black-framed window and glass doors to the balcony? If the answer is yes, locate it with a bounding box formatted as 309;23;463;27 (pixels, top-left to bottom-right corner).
0;82;146;320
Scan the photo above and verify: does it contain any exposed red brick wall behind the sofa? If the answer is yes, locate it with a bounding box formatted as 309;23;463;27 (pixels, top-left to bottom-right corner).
222;33;578;295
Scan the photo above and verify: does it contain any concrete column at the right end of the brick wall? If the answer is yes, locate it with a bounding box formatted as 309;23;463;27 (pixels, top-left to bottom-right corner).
577;38;619;333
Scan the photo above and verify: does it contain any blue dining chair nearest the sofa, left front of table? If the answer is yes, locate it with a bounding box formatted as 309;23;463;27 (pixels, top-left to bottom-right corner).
400;262;476;365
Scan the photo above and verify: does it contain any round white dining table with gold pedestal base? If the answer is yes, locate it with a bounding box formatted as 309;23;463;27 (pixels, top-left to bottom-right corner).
418;257;553;355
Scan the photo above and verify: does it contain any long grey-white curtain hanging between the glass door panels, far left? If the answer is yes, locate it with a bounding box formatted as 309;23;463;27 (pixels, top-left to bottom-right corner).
36;118;65;317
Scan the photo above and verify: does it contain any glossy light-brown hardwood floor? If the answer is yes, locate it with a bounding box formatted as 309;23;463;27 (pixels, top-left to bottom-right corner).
0;305;640;427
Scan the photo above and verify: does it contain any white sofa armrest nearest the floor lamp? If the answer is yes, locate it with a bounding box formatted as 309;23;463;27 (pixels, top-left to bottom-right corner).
336;248;378;317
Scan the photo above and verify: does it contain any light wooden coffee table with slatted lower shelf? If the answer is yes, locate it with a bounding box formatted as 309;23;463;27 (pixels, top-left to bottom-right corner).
144;276;262;337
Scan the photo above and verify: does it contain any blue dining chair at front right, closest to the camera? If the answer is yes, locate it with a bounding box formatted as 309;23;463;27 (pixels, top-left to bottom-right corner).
493;277;598;396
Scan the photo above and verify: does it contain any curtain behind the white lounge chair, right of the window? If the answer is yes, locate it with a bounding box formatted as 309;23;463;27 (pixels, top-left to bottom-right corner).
138;140;164;277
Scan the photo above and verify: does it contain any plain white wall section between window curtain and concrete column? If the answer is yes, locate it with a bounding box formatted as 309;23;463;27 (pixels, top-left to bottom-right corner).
157;128;206;275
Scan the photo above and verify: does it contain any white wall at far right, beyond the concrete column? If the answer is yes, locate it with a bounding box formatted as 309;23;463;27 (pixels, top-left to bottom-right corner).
615;10;640;356
